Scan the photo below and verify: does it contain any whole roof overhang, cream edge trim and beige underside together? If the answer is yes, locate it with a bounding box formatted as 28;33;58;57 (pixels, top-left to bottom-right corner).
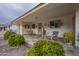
12;3;79;24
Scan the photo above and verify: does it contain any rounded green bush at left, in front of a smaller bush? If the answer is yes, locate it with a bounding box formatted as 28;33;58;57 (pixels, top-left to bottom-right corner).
8;34;24;47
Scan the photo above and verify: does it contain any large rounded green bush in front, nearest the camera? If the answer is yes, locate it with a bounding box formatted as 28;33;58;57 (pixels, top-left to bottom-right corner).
27;40;65;56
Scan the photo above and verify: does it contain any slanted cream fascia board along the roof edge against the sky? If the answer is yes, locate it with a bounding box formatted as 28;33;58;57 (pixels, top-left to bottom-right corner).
11;3;48;24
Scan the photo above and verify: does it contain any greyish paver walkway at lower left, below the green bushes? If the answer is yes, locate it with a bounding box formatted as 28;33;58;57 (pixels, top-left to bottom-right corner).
0;35;27;56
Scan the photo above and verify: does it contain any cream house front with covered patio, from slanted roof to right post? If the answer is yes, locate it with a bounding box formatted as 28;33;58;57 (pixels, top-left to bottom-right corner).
13;4;79;47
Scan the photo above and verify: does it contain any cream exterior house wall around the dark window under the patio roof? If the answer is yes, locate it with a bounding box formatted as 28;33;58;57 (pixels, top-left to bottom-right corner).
17;14;74;37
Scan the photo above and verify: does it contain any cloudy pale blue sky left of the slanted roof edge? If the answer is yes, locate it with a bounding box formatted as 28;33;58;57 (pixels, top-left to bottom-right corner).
0;3;39;24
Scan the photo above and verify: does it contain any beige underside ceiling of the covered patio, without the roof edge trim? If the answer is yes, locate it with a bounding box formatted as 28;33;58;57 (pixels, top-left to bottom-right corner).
13;4;79;23
